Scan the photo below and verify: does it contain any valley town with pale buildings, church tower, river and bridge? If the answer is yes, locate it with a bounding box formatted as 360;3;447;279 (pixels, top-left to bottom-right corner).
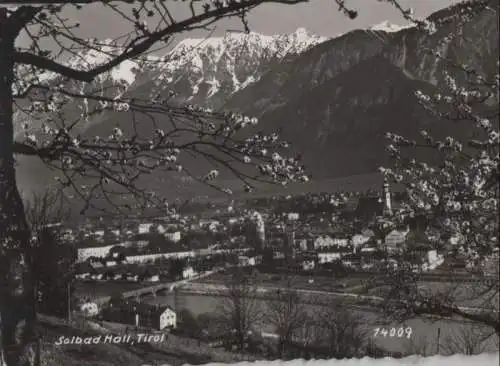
41;180;498;355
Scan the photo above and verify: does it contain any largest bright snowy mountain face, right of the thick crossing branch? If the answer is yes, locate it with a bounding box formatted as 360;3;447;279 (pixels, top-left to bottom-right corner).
154;28;327;104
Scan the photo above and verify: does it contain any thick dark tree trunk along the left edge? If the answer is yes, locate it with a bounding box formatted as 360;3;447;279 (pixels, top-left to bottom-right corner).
0;23;39;366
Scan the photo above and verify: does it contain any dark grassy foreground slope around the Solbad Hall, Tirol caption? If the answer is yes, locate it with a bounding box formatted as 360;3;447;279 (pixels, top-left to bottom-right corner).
38;315;256;366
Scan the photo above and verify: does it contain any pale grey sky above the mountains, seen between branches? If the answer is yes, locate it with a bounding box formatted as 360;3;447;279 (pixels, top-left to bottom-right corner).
16;0;459;50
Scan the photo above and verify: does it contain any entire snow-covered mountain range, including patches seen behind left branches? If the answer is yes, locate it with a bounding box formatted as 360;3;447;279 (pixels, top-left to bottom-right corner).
28;28;326;105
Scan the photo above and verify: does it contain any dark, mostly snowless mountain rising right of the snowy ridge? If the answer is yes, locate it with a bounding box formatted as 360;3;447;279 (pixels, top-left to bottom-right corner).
222;0;498;177
